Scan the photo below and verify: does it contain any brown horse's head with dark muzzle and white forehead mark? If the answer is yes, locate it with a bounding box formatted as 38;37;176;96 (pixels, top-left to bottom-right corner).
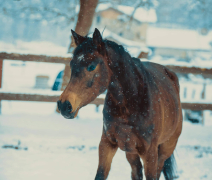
57;29;110;119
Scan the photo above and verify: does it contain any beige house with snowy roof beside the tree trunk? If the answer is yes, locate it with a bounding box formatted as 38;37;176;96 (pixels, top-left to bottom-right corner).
91;4;157;43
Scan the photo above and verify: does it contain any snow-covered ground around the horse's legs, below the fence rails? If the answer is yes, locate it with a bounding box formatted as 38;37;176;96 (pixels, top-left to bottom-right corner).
0;102;212;180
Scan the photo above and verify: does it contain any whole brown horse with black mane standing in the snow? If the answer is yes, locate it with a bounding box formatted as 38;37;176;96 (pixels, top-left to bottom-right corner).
58;29;182;180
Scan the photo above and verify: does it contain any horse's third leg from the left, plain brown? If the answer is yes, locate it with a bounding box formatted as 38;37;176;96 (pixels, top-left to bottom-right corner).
142;145;158;180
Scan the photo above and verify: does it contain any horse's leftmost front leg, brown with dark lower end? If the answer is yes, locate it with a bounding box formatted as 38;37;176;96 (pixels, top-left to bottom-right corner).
95;132;118;180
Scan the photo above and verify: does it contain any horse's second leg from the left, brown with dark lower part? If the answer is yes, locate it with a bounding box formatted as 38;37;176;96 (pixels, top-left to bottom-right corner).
126;153;143;180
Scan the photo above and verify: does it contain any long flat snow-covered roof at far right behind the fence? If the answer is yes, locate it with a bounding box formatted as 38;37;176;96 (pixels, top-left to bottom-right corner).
147;27;212;50
